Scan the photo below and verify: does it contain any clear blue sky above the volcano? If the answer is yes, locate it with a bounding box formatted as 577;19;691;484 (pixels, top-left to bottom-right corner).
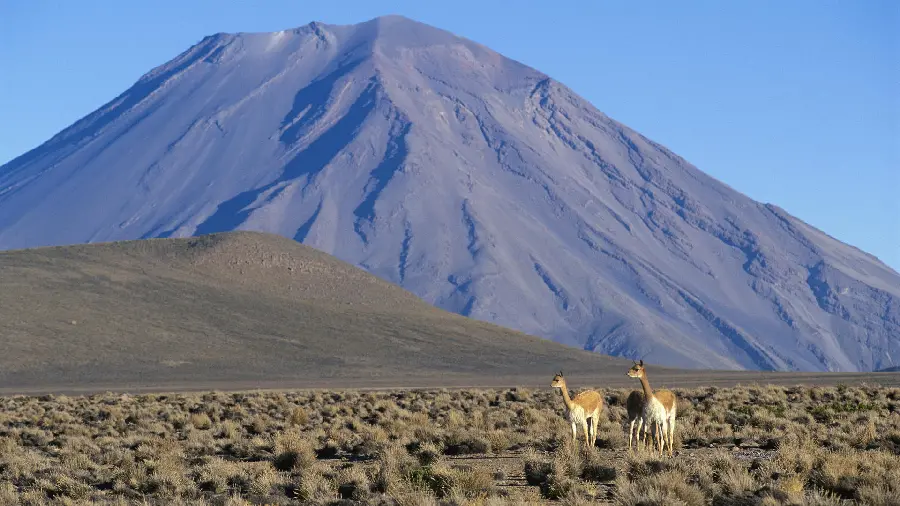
0;0;900;270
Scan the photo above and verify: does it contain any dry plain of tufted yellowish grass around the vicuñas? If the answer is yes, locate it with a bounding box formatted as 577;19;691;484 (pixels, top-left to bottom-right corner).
0;384;900;505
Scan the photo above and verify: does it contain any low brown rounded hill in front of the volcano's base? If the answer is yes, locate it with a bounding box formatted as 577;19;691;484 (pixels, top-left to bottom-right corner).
0;232;900;393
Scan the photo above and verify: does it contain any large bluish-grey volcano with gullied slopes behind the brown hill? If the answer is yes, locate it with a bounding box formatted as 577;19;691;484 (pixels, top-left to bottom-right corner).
0;16;900;371
